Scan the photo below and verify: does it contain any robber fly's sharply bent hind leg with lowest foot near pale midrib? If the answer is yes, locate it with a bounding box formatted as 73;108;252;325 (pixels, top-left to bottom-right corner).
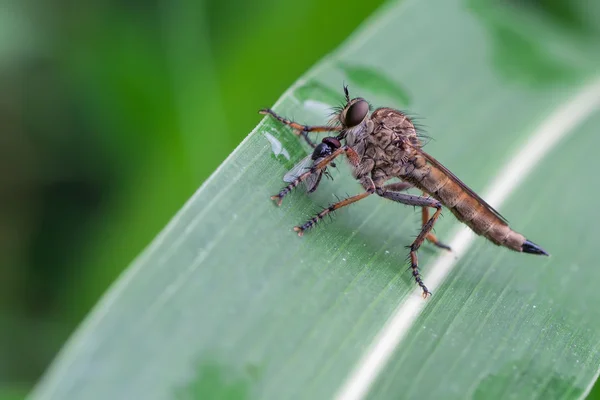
377;189;442;298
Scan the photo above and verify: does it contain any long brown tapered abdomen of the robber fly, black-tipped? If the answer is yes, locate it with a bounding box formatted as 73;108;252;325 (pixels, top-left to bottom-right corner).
401;160;528;254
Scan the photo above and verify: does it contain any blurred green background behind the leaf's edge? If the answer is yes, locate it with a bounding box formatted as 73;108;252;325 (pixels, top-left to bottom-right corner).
0;0;593;398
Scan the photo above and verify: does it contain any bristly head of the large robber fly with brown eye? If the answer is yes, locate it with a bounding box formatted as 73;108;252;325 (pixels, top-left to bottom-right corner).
332;86;373;146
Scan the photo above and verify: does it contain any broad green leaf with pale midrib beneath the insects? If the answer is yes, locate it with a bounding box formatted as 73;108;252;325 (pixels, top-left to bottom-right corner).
32;0;600;399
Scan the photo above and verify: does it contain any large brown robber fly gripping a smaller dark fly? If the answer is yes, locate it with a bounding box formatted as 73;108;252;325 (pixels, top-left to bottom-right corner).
260;87;548;298
